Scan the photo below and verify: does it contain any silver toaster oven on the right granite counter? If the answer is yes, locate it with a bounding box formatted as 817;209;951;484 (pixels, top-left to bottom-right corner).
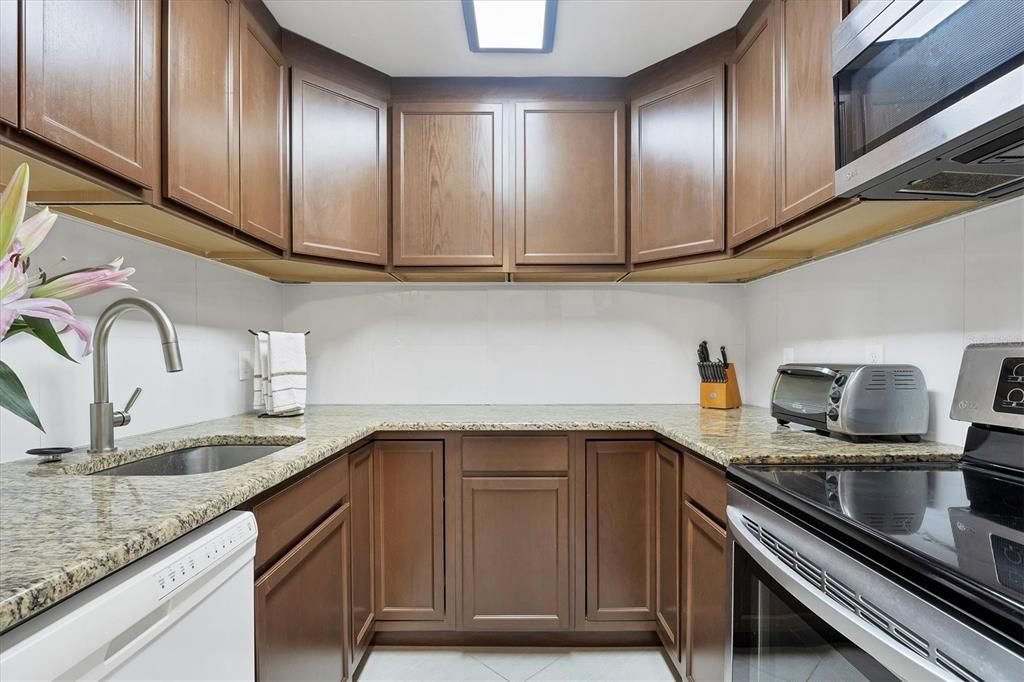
771;364;929;441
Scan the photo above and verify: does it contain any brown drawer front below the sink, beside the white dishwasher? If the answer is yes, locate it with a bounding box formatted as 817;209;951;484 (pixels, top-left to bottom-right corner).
253;455;348;574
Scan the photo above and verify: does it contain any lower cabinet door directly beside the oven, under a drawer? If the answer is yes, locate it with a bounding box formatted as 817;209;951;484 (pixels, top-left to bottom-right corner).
683;502;729;681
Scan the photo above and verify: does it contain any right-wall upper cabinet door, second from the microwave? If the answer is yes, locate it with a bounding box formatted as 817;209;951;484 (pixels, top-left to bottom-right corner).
726;6;778;247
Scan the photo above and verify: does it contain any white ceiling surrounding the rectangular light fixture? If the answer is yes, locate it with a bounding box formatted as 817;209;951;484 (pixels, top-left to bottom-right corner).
265;0;751;76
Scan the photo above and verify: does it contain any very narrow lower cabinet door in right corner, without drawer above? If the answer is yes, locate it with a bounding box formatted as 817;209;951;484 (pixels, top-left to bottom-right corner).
654;445;681;660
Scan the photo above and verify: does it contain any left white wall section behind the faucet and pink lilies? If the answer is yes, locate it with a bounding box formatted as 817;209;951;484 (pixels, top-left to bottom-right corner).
0;217;282;461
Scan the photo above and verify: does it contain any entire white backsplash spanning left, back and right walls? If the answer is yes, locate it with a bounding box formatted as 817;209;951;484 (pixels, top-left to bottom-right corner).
0;199;1024;460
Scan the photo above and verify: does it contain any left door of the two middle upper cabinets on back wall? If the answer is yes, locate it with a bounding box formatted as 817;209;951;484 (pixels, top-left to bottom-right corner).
392;102;503;265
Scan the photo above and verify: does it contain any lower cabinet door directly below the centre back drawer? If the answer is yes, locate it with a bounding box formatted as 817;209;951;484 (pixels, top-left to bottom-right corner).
462;477;569;630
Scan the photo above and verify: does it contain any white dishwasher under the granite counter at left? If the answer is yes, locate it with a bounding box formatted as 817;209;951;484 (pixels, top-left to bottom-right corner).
0;512;257;682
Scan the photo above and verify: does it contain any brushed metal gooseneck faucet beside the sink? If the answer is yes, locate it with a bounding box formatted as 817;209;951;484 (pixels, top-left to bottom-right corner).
89;298;181;453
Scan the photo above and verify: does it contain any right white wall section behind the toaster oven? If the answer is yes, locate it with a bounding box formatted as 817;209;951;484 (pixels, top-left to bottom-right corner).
743;193;1024;443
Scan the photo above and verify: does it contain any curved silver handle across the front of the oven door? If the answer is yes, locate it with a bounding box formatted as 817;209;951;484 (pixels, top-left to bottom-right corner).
726;506;955;681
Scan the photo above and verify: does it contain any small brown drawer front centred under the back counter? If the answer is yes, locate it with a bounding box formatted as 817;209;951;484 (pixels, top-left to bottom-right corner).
462;435;569;473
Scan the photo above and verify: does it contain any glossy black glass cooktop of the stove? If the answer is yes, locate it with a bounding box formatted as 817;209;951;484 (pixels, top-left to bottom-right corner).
741;464;1024;610
